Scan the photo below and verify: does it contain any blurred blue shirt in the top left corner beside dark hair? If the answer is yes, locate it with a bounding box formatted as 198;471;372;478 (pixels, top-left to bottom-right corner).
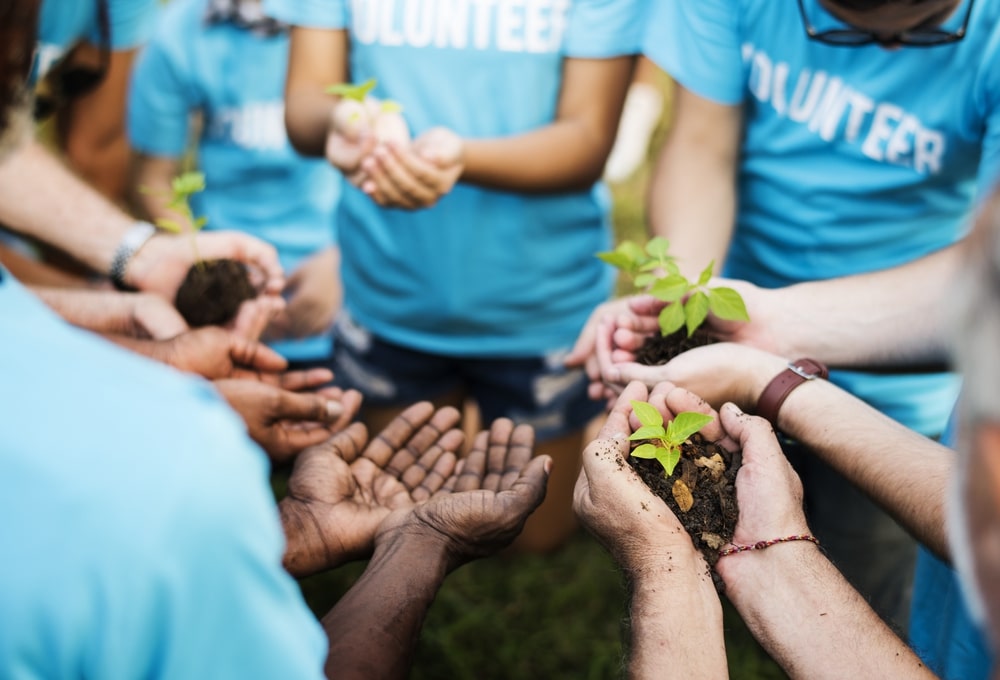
31;0;157;83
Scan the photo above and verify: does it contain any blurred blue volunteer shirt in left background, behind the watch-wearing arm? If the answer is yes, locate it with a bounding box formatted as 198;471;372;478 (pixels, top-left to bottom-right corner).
128;0;340;360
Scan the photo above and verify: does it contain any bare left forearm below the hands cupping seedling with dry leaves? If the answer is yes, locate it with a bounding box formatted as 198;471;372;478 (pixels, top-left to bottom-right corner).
628;559;729;680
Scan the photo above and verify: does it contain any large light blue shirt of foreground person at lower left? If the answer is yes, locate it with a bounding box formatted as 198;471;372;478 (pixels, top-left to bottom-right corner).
0;269;327;680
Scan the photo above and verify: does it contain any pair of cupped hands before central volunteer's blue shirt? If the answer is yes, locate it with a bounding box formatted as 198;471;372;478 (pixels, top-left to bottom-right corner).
326;97;465;210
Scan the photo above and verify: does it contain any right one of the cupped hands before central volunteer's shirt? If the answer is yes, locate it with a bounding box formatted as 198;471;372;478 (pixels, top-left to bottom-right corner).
360;127;465;210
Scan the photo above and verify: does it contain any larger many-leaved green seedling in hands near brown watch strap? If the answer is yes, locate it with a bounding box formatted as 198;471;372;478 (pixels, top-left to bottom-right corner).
597;236;750;337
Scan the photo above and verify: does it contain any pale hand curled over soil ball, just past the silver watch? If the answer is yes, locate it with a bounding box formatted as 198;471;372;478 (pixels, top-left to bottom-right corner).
125;231;285;300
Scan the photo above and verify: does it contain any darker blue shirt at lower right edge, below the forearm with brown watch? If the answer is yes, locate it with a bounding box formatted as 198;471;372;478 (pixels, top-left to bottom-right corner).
910;406;994;680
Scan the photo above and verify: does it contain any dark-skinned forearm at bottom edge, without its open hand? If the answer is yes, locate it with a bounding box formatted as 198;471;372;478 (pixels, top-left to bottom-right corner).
323;536;447;680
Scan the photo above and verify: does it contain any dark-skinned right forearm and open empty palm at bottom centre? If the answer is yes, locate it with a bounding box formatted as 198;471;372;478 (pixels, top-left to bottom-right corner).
323;419;551;678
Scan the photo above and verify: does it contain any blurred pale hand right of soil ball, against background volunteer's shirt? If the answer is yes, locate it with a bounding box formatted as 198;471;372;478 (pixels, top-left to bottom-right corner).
267;246;343;339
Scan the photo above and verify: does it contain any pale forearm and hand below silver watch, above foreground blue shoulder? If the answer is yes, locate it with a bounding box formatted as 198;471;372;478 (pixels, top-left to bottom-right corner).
31;286;188;340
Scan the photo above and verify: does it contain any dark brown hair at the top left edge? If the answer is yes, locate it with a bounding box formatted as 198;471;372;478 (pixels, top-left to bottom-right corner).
0;0;39;132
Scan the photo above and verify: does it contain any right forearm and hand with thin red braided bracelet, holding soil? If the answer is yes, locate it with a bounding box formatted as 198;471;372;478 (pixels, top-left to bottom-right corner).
715;404;934;679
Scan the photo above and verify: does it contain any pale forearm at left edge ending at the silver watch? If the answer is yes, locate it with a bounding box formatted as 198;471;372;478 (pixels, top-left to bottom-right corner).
0;141;133;273
